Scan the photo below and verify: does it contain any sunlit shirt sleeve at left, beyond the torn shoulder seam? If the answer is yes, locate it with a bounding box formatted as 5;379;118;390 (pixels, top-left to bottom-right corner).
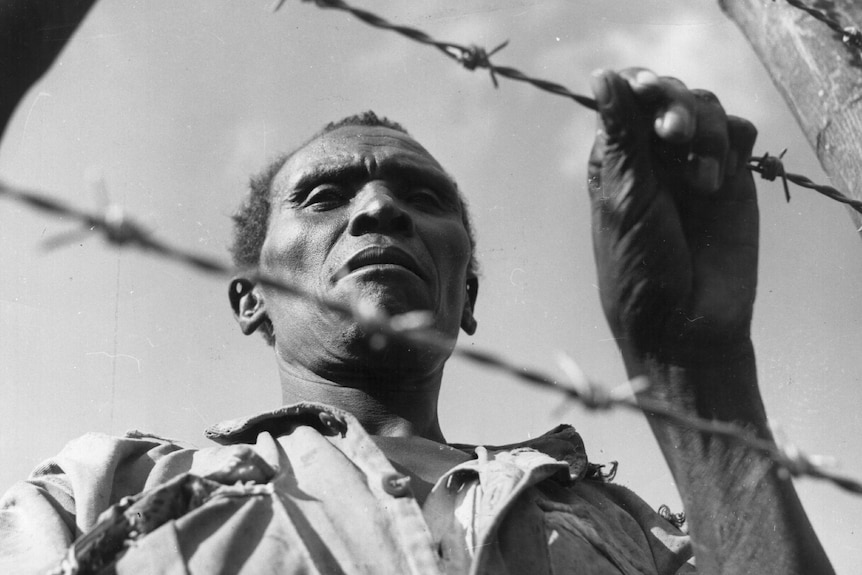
0;433;187;573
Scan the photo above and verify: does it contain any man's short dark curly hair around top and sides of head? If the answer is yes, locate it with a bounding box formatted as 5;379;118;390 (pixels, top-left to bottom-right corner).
230;110;479;345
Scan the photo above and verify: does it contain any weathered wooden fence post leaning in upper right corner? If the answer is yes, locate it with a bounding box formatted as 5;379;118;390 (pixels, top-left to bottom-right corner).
719;0;862;236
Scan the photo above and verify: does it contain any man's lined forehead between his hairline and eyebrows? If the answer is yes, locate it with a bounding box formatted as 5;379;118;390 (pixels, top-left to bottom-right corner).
277;126;445;187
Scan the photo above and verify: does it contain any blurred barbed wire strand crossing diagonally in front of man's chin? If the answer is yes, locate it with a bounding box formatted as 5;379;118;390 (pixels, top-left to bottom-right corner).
0;182;862;495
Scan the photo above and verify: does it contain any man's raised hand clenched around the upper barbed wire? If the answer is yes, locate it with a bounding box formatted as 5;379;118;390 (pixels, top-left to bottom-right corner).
589;68;758;362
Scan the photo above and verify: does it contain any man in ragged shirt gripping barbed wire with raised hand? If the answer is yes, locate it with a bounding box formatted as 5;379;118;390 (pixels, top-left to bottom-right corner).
0;1;831;573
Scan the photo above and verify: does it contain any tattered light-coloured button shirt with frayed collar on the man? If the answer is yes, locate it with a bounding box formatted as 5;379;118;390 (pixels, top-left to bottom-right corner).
0;403;693;575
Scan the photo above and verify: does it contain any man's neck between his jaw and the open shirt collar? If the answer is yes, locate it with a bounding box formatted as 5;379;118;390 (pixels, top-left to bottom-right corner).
276;354;445;443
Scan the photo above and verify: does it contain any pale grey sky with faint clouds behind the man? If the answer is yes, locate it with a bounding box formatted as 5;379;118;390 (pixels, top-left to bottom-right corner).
0;0;862;573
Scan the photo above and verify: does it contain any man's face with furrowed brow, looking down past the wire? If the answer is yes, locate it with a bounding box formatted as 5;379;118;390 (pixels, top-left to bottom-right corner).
261;126;471;372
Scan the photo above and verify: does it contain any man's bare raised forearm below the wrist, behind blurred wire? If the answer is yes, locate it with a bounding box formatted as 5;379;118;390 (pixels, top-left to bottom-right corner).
627;340;833;574
